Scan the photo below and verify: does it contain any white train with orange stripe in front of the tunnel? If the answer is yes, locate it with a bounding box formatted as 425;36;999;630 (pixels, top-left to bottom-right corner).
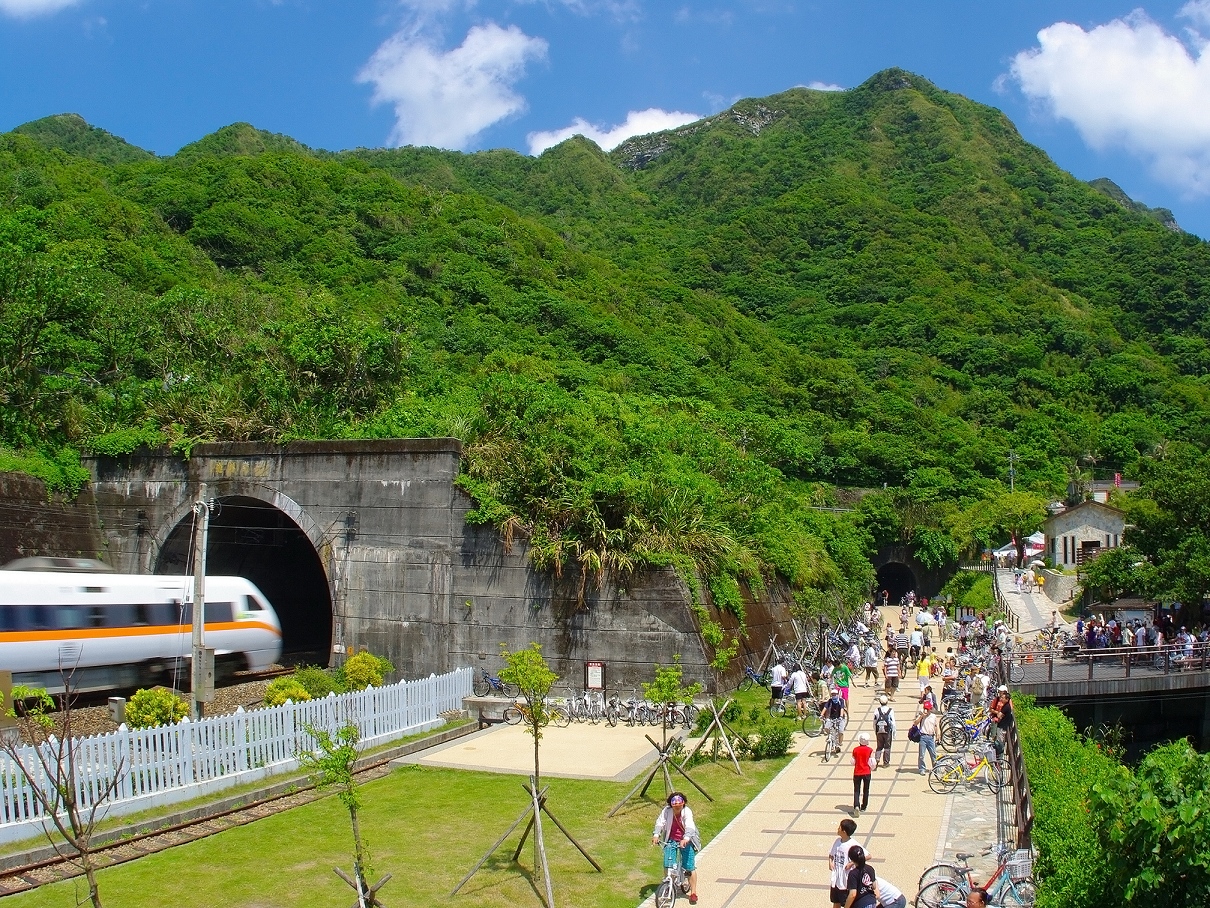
0;563;282;693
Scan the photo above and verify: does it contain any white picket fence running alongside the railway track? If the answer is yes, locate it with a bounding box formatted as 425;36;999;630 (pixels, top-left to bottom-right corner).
0;668;473;843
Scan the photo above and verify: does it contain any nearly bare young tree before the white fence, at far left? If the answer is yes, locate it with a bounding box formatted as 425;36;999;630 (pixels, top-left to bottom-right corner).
0;672;126;908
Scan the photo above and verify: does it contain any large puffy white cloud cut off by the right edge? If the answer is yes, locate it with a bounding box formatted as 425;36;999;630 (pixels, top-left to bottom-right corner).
1010;13;1210;195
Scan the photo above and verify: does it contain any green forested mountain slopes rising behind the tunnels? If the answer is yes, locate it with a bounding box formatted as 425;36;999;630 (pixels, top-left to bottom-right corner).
0;70;1210;612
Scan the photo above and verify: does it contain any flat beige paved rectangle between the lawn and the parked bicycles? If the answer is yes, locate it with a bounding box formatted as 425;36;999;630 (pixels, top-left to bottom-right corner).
394;723;682;782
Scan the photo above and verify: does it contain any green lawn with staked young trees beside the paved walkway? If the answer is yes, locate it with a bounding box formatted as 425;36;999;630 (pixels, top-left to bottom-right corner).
6;726;787;908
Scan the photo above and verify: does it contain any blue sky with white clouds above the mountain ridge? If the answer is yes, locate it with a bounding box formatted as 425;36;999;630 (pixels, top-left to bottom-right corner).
7;0;1210;237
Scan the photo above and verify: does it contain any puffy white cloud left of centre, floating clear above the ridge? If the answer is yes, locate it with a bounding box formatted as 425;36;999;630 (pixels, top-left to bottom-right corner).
358;21;547;149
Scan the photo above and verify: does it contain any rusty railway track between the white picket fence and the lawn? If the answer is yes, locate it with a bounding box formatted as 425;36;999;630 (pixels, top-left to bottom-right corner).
0;752;406;898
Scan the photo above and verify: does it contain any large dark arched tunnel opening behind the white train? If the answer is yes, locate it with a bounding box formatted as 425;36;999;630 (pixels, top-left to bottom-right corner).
155;496;332;666
